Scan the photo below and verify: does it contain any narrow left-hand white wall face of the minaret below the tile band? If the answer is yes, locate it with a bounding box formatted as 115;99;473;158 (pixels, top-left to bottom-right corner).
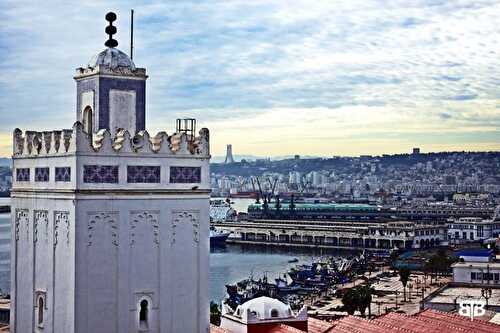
11;195;75;332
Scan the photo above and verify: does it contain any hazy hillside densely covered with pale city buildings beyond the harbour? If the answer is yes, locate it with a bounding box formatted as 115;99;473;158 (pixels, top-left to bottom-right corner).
211;149;500;205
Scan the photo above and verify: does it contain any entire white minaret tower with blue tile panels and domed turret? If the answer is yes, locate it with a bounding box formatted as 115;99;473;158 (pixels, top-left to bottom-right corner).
10;13;210;333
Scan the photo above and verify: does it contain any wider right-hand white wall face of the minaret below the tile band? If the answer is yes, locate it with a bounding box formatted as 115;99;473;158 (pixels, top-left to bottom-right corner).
76;194;209;333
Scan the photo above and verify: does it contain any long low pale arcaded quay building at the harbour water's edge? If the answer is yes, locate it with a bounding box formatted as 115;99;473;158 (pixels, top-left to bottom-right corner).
216;220;444;249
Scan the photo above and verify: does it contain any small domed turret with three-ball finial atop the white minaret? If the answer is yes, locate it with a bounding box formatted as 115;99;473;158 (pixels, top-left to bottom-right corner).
74;13;147;136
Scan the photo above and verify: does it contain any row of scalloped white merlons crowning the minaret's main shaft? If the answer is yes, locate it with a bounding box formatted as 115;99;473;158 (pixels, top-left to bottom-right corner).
13;121;210;158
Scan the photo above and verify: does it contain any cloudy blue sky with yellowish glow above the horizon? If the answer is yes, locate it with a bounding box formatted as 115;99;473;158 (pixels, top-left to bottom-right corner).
0;0;500;156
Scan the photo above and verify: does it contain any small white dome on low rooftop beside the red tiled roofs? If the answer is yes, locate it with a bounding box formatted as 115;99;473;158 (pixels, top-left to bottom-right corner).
235;296;293;320
